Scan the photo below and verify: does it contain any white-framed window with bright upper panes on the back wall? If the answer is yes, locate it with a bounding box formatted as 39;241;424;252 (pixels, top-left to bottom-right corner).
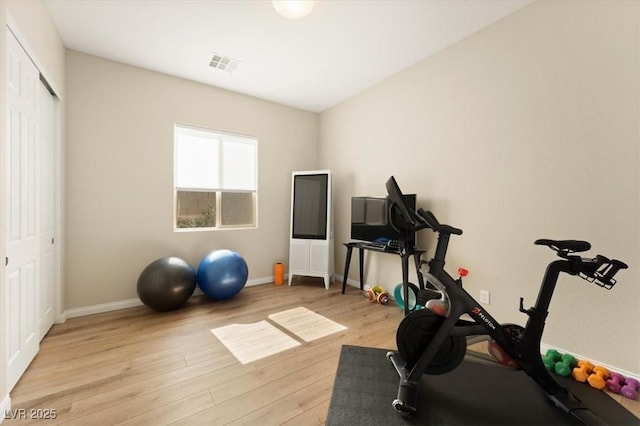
174;125;258;229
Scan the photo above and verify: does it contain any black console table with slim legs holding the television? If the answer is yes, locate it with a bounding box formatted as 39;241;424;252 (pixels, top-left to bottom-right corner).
342;242;426;315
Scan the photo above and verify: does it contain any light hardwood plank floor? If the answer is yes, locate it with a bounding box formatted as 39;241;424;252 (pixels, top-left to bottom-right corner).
3;279;640;425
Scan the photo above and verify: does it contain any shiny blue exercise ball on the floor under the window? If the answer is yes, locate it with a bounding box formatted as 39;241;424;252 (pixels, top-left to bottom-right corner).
197;250;249;300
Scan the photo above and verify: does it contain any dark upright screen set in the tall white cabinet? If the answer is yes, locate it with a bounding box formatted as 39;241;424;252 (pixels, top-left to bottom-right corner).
291;174;329;240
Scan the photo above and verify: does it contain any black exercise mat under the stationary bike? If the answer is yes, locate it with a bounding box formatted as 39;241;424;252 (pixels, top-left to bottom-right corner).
326;345;640;426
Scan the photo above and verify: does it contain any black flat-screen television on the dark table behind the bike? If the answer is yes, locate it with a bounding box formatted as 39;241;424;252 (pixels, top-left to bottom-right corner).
351;194;416;245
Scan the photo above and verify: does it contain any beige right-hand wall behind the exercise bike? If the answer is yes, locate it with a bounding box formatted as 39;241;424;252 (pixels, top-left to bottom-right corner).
320;1;640;375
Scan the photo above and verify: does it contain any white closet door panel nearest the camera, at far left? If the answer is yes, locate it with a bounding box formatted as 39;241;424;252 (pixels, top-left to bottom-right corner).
3;31;40;390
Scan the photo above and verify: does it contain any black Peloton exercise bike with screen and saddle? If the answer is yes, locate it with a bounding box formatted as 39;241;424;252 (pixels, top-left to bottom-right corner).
386;176;627;425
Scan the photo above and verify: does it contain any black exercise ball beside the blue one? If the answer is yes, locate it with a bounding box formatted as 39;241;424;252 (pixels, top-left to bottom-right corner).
138;257;196;312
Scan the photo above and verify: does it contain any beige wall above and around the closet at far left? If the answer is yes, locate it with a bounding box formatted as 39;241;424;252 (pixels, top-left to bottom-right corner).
0;0;65;408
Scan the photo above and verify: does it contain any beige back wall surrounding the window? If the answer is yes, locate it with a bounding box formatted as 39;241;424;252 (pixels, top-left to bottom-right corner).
65;51;318;309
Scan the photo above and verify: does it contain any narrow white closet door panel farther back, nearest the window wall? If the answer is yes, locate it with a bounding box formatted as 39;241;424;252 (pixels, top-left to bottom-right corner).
38;83;56;340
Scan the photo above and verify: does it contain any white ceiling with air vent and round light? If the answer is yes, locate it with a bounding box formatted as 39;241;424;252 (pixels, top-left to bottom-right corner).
46;0;531;112
